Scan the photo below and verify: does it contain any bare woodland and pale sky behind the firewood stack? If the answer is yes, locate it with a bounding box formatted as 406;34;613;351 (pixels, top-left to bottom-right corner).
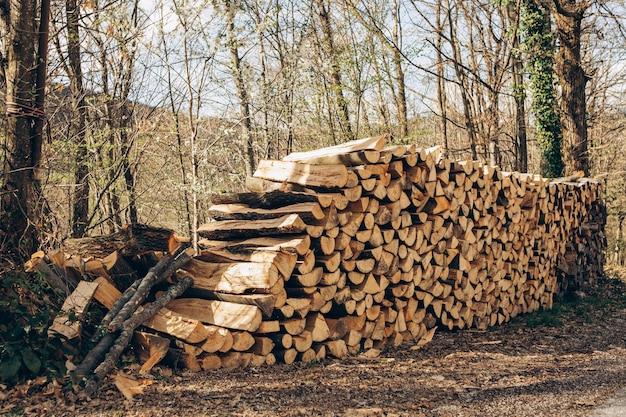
0;0;626;264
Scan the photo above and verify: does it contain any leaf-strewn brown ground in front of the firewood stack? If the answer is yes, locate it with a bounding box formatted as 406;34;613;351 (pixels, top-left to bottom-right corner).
0;270;626;417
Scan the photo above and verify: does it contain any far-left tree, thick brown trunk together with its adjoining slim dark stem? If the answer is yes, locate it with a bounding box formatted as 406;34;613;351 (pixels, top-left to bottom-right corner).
0;0;50;257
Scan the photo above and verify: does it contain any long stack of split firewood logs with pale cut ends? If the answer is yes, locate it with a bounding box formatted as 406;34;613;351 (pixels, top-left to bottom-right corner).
40;136;604;376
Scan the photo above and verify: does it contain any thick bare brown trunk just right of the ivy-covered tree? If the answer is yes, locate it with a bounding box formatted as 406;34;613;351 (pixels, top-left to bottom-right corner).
553;0;591;175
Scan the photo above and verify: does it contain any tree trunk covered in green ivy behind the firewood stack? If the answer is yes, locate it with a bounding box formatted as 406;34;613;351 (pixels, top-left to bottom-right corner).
521;0;564;178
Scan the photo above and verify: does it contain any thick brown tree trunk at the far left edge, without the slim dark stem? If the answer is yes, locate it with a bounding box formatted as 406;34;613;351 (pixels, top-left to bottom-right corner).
0;0;42;256
